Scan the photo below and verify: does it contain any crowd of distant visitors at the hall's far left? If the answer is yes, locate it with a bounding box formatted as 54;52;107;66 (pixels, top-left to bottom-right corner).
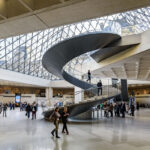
0;102;38;120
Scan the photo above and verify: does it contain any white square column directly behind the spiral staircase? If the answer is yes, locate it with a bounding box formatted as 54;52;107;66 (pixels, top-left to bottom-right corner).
74;86;84;103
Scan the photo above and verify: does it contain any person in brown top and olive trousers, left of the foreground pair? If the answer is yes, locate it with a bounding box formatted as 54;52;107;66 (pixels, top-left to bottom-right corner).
50;107;61;138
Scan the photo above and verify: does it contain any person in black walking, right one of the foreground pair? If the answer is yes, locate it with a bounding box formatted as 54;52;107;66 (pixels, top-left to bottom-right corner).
62;107;69;135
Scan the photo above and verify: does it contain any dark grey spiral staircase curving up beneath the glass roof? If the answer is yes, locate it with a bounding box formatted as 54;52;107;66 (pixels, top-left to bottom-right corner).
42;32;138;118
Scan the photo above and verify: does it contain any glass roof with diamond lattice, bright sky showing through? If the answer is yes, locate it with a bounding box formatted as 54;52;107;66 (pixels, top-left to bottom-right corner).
0;7;150;80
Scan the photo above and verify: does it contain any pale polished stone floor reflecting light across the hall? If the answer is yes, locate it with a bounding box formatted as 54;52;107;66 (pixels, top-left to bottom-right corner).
0;109;150;150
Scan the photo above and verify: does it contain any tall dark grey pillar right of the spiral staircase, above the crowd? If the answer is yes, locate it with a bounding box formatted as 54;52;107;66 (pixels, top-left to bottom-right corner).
121;79;128;101
